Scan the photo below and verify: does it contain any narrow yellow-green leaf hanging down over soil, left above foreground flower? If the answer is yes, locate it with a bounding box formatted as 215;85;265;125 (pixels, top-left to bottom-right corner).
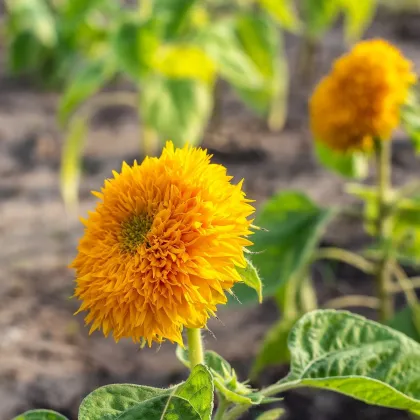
60;117;87;208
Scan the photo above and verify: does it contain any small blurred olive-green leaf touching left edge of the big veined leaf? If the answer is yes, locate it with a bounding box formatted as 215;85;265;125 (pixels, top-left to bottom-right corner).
250;318;297;378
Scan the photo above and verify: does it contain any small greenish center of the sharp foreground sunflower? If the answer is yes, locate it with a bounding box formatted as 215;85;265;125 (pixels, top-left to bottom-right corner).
120;214;153;254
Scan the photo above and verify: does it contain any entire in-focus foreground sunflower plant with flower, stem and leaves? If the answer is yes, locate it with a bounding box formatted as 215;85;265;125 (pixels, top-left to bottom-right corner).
15;142;420;420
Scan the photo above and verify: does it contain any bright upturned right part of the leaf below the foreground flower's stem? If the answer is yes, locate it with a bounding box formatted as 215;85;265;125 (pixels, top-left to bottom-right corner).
175;365;214;420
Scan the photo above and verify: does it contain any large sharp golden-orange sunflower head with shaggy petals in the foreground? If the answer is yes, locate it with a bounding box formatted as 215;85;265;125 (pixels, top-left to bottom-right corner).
71;142;254;346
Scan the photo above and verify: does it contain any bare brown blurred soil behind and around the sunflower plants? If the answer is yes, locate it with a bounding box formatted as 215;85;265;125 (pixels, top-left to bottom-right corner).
0;9;420;420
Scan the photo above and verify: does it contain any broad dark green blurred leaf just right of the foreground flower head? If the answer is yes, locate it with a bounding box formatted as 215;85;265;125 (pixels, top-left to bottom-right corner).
231;191;335;303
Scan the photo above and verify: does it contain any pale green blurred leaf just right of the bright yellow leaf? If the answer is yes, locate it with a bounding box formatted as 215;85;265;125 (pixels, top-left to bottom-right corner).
197;19;264;89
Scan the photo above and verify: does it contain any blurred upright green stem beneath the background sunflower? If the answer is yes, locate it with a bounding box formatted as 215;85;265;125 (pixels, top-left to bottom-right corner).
375;139;394;322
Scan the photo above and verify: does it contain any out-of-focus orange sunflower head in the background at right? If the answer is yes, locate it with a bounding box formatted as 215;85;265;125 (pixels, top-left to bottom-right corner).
310;39;416;151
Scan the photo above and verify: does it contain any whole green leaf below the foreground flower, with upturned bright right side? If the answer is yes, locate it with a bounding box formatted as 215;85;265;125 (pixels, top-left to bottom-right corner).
78;365;213;420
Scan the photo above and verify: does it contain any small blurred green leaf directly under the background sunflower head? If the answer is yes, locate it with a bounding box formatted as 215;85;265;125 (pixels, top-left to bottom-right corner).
315;141;369;179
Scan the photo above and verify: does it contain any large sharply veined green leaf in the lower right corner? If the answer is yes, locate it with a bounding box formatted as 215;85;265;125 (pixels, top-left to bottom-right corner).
280;310;420;414
